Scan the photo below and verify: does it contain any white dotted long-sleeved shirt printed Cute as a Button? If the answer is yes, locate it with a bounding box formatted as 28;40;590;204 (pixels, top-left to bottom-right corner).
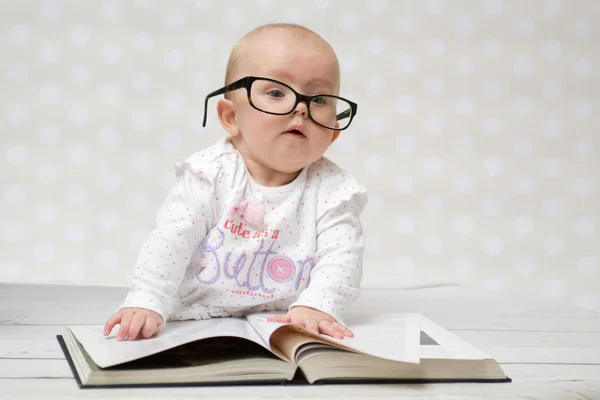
121;137;367;323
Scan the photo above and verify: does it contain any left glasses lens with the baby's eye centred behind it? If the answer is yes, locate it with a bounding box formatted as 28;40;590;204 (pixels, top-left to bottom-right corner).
250;79;296;114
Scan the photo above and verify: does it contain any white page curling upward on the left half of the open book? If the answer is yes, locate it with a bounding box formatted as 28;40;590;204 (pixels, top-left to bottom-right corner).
69;318;270;368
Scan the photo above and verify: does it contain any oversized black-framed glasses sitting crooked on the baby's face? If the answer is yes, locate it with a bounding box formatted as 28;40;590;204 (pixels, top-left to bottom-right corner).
202;76;358;131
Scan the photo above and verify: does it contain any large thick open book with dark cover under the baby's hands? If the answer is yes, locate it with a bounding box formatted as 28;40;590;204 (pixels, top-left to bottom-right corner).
57;313;510;387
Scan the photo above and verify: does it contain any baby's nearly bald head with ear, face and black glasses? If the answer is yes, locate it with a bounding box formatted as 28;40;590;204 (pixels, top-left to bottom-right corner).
209;24;356;187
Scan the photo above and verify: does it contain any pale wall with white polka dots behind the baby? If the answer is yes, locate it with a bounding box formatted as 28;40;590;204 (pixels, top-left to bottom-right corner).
0;0;600;309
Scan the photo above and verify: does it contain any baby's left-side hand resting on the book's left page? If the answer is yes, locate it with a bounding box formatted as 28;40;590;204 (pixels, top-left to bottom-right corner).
104;307;164;341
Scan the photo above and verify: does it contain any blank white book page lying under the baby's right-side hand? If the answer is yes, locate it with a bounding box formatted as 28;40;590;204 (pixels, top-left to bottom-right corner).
247;313;421;363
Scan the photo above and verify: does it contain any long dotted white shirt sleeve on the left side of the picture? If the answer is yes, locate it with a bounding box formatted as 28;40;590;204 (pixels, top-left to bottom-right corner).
120;163;213;322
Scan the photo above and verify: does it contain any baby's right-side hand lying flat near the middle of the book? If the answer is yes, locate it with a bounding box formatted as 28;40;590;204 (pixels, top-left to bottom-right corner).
267;306;354;339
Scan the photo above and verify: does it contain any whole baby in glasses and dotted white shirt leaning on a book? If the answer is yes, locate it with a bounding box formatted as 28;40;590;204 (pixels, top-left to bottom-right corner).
104;24;366;340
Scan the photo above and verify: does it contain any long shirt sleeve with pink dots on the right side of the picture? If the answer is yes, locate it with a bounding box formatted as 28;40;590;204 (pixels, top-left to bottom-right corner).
290;176;367;324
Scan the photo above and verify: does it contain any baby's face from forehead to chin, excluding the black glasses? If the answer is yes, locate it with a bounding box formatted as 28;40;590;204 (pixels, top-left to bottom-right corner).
231;31;339;174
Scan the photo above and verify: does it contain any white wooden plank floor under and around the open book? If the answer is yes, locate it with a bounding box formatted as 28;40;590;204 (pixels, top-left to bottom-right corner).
0;284;600;400
